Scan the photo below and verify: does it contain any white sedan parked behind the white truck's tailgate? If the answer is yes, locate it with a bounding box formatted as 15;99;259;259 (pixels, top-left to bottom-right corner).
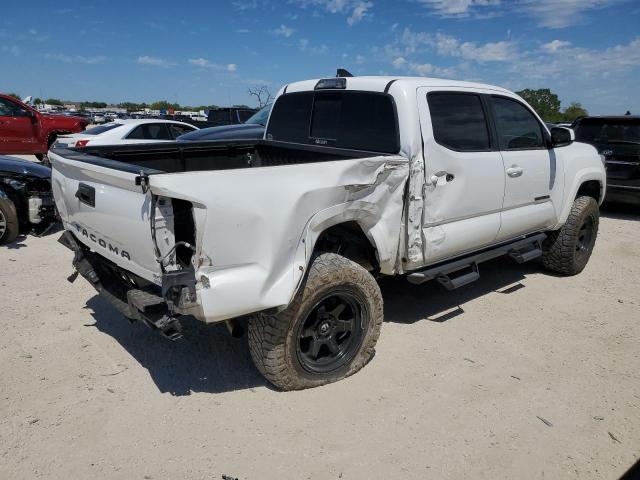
56;119;198;148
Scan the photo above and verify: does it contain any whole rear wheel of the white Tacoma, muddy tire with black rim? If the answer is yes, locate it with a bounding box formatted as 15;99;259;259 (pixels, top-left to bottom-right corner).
249;253;383;390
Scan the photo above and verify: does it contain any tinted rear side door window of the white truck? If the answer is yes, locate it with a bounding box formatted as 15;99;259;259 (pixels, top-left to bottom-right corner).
427;92;491;152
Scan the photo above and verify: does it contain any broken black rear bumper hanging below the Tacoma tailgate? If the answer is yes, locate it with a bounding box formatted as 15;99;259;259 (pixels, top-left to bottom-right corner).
58;231;196;340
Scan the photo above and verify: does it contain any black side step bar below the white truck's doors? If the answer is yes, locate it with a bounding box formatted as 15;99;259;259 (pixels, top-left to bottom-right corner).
407;233;547;290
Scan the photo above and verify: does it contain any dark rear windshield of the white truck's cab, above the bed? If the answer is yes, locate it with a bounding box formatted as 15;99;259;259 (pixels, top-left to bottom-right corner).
267;90;400;153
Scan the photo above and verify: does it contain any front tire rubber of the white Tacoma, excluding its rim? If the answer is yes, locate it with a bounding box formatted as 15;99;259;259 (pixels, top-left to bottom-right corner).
542;197;600;275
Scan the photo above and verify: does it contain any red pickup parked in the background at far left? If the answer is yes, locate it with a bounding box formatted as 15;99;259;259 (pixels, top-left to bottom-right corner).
0;93;89;160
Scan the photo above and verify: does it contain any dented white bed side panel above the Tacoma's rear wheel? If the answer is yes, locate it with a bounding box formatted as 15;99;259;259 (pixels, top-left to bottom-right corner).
150;156;409;322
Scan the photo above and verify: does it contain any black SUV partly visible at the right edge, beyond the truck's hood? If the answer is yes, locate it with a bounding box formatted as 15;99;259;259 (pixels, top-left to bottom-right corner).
572;115;640;204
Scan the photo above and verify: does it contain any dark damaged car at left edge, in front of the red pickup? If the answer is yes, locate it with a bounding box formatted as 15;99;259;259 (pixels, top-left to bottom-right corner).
0;155;56;245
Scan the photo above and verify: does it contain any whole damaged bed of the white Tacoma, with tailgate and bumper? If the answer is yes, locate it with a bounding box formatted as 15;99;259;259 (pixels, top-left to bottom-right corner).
50;140;408;336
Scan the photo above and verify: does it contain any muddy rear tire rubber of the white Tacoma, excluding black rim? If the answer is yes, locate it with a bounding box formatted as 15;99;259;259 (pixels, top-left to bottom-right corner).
248;253;383;390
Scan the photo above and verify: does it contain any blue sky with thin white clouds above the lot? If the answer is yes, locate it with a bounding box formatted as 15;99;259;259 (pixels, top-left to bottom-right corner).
0;0;640;114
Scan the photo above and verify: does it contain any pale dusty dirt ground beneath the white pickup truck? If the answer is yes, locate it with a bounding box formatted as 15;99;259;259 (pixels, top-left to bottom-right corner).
0;194;640;480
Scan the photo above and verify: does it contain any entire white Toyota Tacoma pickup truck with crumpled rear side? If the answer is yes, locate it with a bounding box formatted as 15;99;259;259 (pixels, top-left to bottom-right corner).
49;77;606;390
